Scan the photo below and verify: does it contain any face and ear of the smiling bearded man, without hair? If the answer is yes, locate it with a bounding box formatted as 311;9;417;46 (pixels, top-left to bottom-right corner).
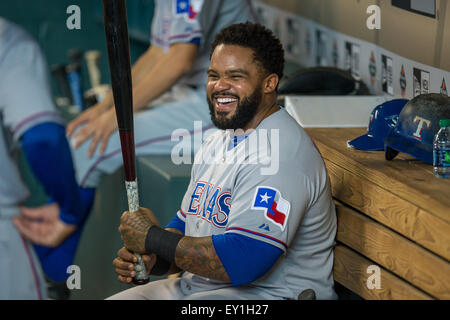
206;44;283;131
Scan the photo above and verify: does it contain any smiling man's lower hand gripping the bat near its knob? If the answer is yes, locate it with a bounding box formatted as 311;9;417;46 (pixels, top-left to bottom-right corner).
113;247;156;283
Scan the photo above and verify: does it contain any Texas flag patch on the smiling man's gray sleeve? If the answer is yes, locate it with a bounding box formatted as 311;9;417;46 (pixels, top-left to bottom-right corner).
252;186;291;231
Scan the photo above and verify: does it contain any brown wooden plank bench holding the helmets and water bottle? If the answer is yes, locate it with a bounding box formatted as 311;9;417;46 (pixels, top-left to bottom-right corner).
306;128;450;300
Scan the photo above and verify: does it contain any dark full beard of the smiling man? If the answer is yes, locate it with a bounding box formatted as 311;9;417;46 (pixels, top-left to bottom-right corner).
207;86;262;130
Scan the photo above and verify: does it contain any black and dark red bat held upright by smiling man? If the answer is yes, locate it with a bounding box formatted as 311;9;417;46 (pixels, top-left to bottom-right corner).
103;0;149;284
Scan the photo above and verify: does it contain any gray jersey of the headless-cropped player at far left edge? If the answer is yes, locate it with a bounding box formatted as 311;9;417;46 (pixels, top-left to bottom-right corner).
0;17;62;217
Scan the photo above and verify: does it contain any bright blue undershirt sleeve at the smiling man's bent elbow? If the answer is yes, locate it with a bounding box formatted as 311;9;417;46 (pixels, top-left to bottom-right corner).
212;233;283;286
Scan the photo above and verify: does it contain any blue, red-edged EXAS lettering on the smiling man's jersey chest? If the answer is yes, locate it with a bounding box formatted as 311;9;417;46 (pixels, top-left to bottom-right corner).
186;181;231;228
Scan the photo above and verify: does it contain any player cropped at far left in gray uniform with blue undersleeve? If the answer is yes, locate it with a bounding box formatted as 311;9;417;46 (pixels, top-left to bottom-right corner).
0;17;93;299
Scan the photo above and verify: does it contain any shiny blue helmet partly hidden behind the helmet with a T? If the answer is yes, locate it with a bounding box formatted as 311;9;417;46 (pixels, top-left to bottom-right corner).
347;99;408;151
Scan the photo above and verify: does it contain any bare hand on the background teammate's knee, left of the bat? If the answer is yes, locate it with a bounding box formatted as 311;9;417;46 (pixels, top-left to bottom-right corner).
67;104;117;157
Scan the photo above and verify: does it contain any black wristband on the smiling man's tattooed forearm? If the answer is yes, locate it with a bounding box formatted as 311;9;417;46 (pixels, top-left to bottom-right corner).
145;226;183;263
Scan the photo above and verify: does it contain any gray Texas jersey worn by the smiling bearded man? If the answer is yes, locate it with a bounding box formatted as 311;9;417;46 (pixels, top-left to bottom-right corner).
177;109;336;299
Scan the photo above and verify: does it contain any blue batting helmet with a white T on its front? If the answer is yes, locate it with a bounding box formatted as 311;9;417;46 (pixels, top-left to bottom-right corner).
384;93;450;164
